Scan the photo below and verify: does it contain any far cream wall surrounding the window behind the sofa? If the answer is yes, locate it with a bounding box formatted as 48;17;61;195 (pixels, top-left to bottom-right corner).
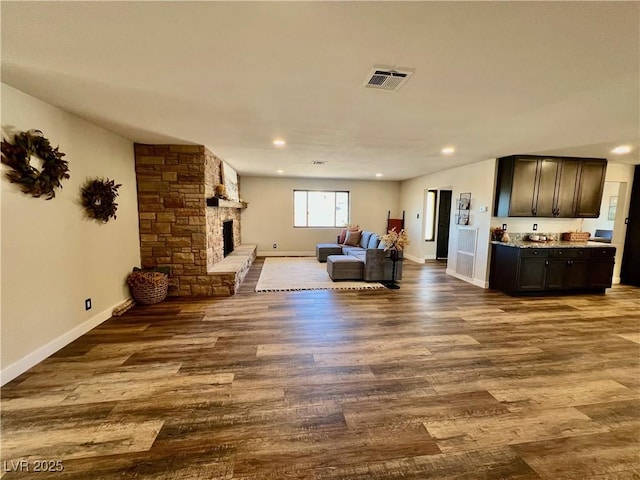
240;176;402;256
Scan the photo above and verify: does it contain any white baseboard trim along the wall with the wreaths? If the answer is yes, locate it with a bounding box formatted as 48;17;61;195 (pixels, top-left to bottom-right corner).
0;301;122;385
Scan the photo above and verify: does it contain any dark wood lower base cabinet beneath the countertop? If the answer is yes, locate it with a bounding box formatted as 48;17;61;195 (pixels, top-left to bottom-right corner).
489;244;616;294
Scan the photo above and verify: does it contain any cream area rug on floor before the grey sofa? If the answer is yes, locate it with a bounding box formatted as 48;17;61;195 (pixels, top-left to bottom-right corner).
256;257;384;292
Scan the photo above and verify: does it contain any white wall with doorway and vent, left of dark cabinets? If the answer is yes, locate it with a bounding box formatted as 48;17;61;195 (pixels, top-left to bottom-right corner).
400;159;496;287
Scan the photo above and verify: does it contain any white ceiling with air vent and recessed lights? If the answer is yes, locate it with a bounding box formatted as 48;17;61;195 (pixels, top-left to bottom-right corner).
2;1;640;180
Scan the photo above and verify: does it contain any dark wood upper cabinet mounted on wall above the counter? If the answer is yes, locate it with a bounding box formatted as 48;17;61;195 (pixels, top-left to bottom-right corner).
494;155;607;218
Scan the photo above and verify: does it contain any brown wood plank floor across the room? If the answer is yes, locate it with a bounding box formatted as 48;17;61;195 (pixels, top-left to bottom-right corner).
1;262;640;480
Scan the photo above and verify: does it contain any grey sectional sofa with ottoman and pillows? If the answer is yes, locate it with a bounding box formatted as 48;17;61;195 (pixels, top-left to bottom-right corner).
316;230;402;282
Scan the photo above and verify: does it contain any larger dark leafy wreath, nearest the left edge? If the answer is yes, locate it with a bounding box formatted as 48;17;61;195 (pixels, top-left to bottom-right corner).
2;130;69;200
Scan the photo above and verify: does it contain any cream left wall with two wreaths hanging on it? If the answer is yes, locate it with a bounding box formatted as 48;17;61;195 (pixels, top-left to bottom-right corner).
0;84;140;384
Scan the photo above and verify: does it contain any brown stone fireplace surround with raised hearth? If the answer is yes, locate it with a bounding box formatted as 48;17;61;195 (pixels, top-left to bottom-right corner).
134;144;255;296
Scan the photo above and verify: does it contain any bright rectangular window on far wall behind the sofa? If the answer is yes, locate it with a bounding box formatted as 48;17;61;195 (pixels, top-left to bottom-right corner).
293;190;349;227
